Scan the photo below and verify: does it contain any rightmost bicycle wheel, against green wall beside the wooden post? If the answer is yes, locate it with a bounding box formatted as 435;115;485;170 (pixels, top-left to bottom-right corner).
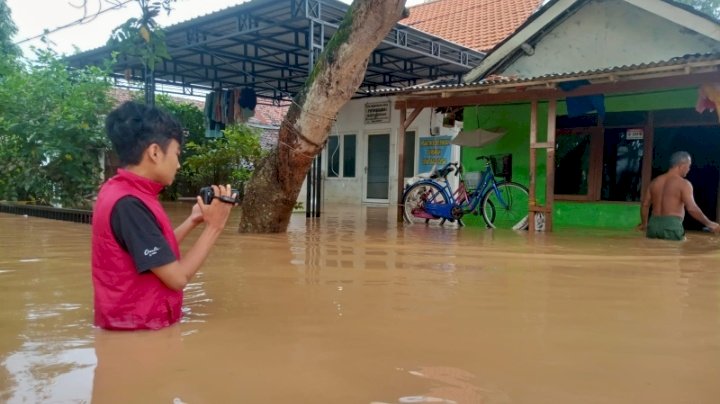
481;182;529;230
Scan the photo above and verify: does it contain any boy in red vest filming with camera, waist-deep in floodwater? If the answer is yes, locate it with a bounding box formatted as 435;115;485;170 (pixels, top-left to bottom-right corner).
92;102;234;330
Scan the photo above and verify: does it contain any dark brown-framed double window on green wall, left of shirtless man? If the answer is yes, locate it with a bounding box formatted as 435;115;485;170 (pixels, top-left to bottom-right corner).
555;112;647;202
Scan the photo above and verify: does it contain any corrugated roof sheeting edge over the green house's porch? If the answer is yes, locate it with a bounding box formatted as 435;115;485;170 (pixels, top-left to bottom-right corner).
372;53;720;95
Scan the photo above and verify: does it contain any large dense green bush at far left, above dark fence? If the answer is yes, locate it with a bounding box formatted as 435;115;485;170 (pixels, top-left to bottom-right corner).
0;50;111;207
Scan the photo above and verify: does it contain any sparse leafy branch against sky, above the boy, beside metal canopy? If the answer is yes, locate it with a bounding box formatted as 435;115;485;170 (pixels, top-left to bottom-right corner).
108;0;176;72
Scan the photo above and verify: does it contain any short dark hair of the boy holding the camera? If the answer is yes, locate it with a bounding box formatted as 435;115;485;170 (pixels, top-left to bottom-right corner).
105;101;183;165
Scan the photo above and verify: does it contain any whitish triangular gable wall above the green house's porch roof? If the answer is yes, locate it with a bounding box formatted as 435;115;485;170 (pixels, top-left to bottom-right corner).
502;0;720;77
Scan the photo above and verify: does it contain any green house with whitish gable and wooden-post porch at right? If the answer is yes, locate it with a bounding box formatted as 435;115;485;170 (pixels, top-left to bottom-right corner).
386;0;720;230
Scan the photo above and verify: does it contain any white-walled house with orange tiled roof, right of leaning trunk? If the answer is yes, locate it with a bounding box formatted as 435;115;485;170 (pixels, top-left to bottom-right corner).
322;0;542;204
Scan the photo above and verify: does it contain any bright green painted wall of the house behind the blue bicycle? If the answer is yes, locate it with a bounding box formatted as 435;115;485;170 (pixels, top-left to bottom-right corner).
461;88;698;228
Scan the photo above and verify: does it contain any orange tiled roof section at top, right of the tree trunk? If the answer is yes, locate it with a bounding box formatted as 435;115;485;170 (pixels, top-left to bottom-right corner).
400;0;542;52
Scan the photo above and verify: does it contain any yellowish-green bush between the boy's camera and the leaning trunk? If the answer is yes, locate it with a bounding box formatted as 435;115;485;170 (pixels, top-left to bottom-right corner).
183;125;264;189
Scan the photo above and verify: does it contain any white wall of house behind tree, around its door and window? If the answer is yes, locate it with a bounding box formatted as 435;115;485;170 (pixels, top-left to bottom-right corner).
323;97;462;204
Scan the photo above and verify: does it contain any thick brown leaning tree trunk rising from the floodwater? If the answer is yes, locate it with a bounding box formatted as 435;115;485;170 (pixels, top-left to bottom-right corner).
240;0;406;233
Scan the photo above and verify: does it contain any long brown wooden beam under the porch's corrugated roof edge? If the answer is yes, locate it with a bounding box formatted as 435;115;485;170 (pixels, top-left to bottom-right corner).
395;71;720;109
